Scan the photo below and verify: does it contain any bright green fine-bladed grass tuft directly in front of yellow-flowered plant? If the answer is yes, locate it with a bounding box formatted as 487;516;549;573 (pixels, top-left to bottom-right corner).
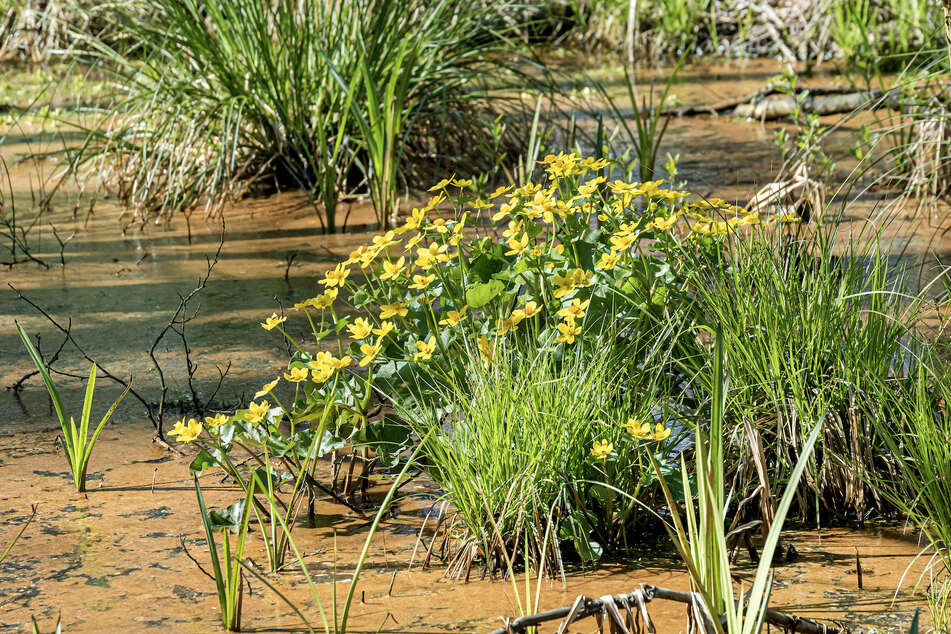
396;338;678;570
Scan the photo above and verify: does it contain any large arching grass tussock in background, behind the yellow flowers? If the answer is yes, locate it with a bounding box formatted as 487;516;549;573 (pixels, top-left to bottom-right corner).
70;0;536;231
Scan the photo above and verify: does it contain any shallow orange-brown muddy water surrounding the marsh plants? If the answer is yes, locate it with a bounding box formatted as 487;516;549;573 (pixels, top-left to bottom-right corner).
0;58;940;632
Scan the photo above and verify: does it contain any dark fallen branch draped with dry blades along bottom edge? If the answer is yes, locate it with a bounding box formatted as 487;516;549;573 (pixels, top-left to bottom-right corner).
491;583;841;634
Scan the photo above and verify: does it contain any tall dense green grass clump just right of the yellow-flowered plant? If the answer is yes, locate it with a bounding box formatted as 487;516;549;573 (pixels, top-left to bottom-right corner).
671;223;923;522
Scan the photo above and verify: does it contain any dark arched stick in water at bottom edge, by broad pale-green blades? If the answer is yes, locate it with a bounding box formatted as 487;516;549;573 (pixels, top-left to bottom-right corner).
491;583;840;634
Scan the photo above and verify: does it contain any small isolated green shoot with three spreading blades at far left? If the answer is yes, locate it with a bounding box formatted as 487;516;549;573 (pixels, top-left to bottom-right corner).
16;324;132;493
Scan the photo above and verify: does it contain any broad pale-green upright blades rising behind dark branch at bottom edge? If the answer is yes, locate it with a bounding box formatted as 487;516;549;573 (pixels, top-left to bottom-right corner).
648;333;823;634
